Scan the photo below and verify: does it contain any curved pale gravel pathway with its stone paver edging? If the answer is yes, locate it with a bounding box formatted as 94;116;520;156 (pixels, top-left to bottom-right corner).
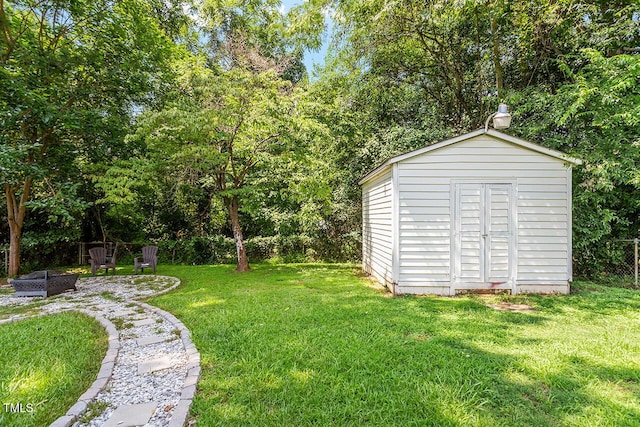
0;276;200;427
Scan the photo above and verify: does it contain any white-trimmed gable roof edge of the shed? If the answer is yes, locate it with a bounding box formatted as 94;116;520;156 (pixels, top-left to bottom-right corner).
358;129;582;185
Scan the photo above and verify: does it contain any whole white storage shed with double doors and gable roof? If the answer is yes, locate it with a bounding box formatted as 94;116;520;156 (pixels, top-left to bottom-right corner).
360;129;581;295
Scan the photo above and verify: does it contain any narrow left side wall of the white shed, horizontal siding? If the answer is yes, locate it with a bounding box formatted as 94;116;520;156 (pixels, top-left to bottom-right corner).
362;171;393;285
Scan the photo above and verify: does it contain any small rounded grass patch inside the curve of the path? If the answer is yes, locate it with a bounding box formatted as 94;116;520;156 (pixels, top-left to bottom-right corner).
0;309;107;427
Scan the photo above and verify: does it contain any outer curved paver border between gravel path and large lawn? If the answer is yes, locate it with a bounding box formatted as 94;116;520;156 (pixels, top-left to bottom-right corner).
135;302;200;427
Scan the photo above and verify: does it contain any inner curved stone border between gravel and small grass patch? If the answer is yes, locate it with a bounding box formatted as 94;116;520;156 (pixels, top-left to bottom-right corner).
49;310;120;427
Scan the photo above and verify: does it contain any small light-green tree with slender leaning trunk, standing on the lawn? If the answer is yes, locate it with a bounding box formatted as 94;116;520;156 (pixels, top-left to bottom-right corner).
127;59;297;271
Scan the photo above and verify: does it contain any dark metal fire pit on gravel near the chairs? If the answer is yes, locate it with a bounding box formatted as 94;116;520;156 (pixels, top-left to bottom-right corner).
8;270;78;297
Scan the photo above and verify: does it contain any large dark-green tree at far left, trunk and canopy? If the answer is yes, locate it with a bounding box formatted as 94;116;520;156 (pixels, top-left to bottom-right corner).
0;0;168;275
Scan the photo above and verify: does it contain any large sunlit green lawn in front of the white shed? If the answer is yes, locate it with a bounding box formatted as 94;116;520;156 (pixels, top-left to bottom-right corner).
150;264;640;426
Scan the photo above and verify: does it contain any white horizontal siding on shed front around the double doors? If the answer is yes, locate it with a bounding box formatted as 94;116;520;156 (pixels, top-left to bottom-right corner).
397;135;570;292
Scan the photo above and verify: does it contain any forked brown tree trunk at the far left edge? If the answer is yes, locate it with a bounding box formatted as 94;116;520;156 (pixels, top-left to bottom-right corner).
4;178;32;276
